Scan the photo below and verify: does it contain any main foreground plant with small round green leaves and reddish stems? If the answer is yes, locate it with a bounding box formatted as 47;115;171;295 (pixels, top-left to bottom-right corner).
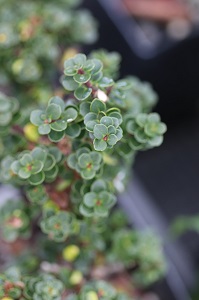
0;52;166;300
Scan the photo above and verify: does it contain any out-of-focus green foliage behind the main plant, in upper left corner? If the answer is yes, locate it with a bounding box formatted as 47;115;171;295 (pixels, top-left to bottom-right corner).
0;0;97;104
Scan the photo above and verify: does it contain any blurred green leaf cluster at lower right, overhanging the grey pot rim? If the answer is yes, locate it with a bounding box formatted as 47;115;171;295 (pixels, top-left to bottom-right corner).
112;229;166;286
